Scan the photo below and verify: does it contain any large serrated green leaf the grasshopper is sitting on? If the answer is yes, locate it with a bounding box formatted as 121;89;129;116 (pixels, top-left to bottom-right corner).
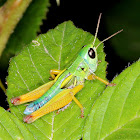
7;21;106;140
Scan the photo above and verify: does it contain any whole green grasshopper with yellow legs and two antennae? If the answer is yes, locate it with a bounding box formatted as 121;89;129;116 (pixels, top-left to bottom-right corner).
11;14;122;123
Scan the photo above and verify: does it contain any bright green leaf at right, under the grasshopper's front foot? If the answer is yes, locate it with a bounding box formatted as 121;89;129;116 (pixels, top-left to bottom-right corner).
84;60;140;140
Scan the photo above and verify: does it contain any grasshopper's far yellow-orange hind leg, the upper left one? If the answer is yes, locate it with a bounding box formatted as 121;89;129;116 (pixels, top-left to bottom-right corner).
11;80;54;105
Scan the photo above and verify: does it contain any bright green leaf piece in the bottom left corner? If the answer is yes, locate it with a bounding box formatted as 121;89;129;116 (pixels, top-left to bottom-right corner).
0;107;34;140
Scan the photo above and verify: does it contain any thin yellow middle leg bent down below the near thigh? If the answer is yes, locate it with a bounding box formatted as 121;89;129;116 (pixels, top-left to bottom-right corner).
70;85;84;118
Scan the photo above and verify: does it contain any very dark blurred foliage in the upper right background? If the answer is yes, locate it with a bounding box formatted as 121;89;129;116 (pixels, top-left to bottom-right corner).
106;0;140;61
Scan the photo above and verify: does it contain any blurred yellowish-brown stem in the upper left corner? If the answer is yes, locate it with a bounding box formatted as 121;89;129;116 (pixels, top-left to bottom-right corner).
0;0;32;56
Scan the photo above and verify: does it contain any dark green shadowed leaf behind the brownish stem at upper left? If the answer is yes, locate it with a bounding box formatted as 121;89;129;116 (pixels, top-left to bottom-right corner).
0;0;50;69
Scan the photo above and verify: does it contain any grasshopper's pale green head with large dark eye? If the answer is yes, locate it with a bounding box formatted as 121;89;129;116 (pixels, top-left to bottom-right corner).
79;44;98;72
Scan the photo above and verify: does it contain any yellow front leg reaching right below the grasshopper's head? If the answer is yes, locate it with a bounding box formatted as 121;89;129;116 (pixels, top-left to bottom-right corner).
88;74;116;86
